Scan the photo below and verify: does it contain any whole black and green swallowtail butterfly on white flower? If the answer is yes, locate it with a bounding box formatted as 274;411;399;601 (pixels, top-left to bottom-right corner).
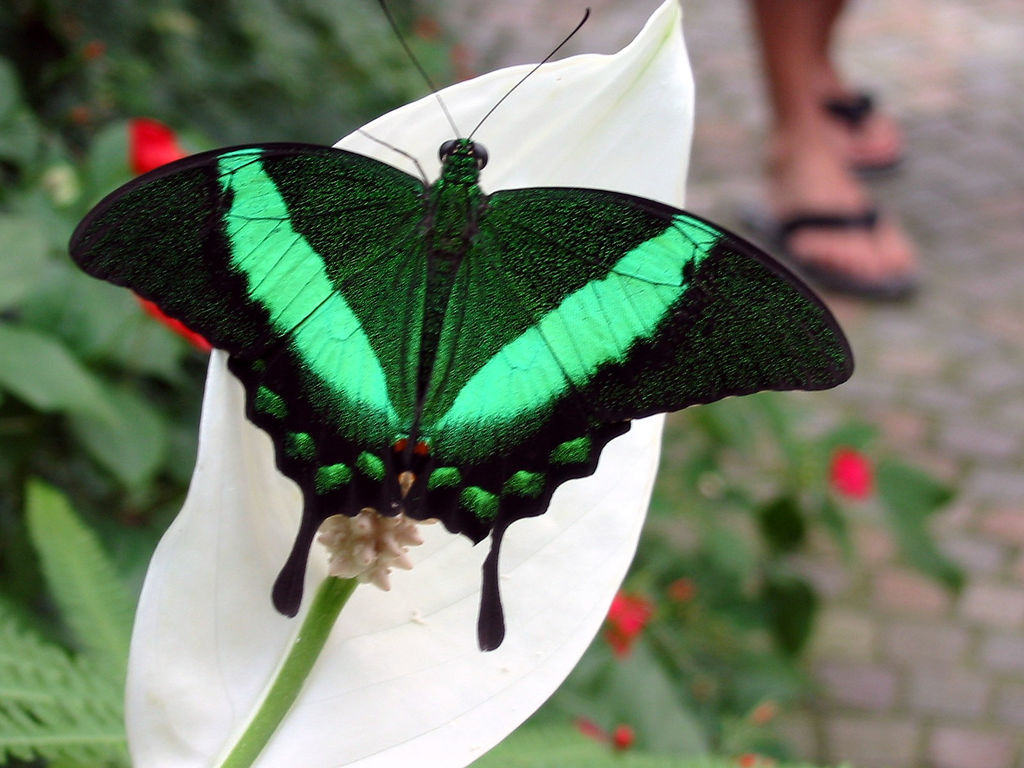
71;139;852;649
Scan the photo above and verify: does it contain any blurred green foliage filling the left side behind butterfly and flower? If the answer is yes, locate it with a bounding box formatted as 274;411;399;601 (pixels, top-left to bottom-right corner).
0;0;450;766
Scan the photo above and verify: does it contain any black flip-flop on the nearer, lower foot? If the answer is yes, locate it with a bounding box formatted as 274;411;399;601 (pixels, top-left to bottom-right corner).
740;208;918;301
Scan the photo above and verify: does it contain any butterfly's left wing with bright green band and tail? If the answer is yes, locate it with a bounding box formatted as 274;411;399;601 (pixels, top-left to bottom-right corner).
71;144;426;613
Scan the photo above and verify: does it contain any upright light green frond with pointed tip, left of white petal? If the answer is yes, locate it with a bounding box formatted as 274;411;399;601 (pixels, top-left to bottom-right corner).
26;480;132;679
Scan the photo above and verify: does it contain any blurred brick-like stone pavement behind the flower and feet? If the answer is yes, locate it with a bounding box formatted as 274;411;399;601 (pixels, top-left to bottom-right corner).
443;0;1024;768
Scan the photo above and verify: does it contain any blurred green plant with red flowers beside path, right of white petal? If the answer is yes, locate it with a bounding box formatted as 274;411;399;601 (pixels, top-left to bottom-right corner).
536;393;961;759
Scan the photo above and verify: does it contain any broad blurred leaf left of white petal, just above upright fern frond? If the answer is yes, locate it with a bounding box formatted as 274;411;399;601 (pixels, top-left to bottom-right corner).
71;387;168;486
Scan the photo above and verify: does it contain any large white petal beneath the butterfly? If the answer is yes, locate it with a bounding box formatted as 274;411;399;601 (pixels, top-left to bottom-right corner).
127;0;693;768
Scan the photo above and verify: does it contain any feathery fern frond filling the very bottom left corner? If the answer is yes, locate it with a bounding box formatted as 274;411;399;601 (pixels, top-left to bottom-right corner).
0;600;129;766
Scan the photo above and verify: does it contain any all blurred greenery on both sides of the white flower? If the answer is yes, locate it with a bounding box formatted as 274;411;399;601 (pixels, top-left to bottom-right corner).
0;0;958;766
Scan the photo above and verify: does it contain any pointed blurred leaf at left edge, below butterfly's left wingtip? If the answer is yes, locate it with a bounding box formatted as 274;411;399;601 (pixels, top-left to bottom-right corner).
0;323;117;423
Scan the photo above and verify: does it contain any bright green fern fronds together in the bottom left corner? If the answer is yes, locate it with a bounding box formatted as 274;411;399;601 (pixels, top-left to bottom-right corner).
0;480;133;768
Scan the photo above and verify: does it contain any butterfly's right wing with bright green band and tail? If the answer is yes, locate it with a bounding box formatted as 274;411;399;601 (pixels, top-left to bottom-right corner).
411;188;852;647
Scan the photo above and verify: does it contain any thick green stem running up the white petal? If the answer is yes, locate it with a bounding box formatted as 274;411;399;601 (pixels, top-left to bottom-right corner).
220;577;358;768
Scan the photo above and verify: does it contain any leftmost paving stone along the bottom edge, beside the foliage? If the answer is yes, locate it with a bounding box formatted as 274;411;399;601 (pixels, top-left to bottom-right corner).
822;716;921;768
